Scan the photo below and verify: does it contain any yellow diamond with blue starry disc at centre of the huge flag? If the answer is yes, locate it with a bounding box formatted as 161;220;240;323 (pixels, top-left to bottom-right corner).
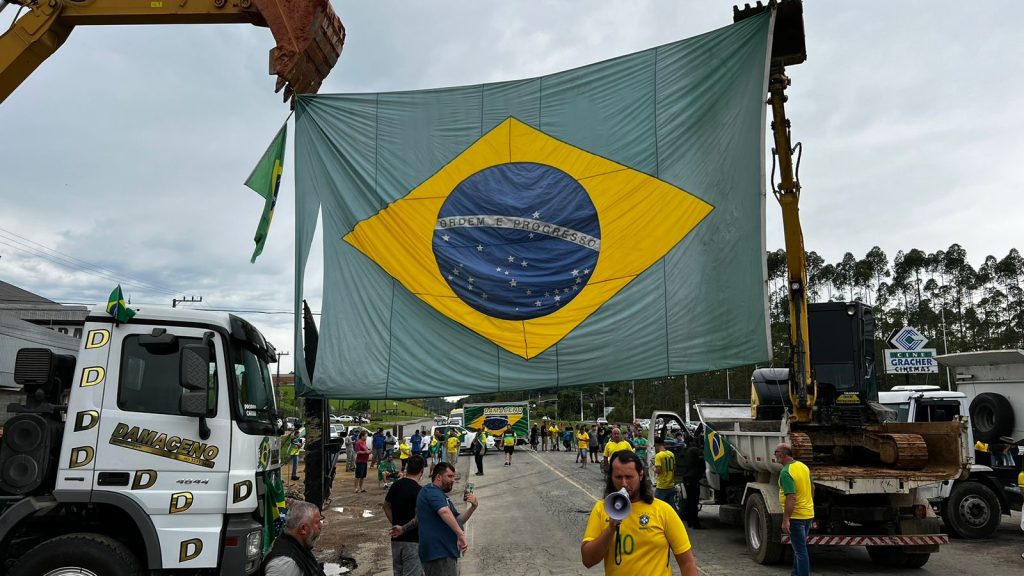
345;118;713;360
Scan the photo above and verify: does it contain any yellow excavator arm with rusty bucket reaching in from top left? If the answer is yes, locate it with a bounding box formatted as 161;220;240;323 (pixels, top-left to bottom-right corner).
0;0;345;102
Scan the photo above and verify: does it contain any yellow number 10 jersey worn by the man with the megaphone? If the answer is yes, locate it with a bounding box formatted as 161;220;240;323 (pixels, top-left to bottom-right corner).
583;498;690;576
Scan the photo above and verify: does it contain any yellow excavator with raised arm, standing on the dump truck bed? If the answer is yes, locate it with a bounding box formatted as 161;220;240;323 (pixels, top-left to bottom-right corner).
733;0;929;470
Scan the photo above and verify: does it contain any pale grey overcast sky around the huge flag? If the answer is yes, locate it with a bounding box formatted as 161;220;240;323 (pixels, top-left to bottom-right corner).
0;0;1024;372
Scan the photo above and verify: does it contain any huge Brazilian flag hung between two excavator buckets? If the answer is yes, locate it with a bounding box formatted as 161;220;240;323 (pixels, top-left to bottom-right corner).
294;13;771;399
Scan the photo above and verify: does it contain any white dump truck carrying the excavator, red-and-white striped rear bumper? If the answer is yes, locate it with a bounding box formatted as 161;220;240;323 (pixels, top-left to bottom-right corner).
651;403;969;568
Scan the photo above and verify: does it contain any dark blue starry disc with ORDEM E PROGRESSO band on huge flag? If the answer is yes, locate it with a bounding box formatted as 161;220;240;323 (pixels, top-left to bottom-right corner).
433;162;601;320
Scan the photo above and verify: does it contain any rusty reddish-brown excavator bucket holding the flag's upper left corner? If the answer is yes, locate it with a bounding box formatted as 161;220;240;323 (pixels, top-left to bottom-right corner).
252;0;345;101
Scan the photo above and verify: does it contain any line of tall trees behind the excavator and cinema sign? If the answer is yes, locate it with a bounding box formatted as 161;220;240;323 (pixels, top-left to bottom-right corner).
460;244;1024;422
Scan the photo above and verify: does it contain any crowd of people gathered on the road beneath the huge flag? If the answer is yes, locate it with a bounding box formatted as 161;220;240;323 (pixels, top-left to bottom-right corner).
264;419;831;576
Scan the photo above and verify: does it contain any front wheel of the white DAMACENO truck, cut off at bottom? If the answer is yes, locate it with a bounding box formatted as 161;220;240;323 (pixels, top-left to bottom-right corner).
10;532;143;576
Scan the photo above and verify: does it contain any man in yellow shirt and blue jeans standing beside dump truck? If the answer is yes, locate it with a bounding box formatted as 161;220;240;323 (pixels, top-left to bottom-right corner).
775;442;814;576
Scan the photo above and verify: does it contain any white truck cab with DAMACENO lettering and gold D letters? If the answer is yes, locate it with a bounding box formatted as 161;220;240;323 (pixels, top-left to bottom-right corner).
0;306;281;576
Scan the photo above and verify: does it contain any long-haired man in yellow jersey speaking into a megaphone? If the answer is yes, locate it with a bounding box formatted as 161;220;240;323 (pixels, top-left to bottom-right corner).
581;450;697;576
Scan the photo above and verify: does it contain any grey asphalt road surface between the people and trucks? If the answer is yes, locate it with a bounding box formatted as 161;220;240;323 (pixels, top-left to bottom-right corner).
453;449;1024;576
